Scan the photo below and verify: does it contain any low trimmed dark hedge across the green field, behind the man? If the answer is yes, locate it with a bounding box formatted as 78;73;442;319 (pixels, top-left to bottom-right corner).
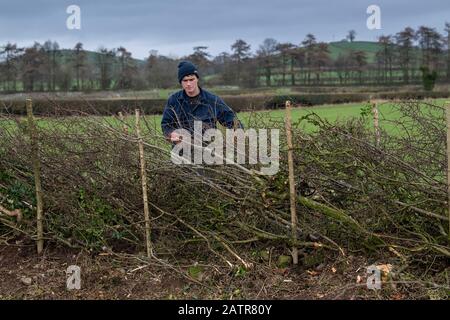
0;91;450;115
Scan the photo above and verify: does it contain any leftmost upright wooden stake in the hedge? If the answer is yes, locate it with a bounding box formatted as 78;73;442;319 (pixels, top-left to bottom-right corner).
26;99;44;254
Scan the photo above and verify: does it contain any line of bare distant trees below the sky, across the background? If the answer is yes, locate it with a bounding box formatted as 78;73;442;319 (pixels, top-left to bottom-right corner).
0;23;450;93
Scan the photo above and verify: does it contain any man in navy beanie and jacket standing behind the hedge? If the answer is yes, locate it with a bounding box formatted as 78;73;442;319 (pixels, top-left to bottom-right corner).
161;61;242;144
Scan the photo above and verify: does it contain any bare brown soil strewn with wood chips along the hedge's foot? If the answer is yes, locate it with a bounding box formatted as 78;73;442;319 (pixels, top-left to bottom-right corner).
0;245;432;300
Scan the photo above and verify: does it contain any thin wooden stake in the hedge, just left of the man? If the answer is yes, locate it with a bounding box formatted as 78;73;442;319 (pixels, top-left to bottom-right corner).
136;109;152;258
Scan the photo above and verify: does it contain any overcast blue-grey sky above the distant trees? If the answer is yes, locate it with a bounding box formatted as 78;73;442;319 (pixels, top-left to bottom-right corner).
0;0;450;59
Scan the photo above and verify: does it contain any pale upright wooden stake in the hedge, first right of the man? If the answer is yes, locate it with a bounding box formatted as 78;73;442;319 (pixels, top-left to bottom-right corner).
285;101;298;264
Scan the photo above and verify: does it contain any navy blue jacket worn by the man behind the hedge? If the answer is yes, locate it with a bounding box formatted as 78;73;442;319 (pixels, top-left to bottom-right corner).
161;88;242;137
